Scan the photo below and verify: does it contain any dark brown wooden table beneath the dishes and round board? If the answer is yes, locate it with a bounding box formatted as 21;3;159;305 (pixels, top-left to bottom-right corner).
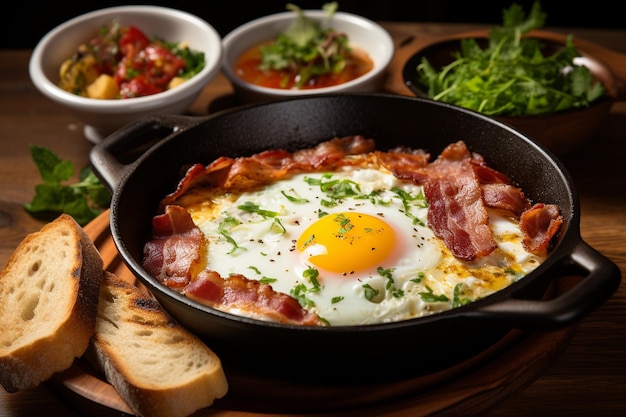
0;23;626;417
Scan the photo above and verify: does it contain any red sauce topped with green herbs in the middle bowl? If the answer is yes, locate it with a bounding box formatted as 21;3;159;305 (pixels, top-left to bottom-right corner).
235;3;374;89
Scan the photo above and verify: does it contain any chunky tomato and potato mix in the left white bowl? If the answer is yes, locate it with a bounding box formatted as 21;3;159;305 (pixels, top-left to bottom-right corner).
59;21;205;99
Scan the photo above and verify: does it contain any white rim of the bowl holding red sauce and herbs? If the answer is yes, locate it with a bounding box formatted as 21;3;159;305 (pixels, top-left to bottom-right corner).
222;10;395;97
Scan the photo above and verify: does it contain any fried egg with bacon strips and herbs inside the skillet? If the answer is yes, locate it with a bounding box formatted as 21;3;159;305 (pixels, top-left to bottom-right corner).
143;136;563;326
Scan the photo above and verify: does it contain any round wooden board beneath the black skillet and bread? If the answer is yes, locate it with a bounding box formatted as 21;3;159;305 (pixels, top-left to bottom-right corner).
49;211;576;417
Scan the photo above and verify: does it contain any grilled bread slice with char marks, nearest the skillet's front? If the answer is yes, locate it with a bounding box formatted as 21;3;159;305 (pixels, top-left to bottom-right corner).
87;272;228;417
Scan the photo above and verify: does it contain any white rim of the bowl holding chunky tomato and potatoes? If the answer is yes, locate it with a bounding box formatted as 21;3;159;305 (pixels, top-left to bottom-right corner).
29;5;223;113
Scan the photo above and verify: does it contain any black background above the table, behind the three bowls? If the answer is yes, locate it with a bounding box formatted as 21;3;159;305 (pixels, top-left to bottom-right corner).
0;0;626;49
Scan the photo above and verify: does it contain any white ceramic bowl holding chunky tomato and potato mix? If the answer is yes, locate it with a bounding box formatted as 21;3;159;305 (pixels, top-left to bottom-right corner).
29;6;223;142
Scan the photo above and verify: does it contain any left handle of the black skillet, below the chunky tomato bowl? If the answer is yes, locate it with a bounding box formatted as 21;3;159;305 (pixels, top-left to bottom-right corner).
89;115;200;191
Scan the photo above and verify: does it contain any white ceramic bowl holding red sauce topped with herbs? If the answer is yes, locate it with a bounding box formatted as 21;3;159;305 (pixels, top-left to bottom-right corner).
222;10;394;102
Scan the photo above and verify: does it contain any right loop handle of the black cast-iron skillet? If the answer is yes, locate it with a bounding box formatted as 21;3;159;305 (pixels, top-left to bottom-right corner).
477;240;621;330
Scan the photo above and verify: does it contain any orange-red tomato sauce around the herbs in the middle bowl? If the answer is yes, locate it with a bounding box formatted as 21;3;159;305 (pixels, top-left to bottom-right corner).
235;42;374;90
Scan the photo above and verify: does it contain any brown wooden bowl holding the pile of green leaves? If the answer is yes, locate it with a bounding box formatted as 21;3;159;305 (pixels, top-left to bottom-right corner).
402;30;626;154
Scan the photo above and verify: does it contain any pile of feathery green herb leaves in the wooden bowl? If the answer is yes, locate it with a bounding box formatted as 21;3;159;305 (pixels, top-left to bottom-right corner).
417;1;604;116
